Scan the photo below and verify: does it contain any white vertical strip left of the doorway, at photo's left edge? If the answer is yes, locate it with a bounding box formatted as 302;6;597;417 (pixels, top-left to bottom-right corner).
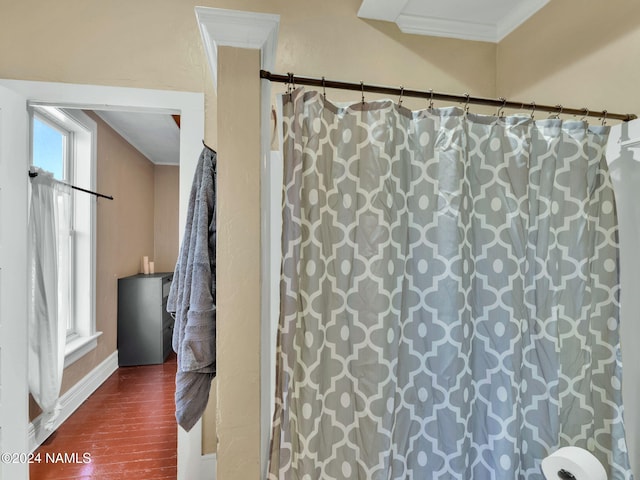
0;86;29;480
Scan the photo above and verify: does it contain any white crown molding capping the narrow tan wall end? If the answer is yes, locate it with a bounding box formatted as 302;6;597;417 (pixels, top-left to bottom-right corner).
195;7;280;91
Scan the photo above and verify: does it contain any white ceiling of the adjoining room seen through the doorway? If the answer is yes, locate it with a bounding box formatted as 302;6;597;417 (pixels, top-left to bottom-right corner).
96;110;180;165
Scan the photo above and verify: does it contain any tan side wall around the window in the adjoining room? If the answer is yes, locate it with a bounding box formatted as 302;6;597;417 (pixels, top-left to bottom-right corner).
62;112;154;392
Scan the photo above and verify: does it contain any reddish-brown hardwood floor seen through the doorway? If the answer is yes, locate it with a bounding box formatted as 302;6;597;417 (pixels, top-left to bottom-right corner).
30;353;177;480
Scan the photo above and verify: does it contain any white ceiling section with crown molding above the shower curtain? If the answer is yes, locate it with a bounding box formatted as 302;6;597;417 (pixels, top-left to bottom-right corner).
358;0;549;43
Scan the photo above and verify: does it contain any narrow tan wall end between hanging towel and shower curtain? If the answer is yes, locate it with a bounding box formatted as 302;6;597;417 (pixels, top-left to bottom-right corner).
216;47;261;479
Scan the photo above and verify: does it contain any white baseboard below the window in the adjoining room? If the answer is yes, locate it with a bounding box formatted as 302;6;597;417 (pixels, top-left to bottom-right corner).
29;350;118;452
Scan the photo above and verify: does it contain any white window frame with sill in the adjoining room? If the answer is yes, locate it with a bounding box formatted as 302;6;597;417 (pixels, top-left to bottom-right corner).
29;105;102;368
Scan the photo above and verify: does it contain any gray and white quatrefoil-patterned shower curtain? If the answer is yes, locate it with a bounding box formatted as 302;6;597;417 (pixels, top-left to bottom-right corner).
269;89;632;480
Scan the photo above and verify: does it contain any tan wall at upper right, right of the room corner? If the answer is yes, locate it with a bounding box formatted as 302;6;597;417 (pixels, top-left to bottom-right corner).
497;0;640;118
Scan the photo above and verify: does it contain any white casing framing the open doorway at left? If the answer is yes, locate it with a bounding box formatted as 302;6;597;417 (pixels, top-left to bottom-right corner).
0;79;204;480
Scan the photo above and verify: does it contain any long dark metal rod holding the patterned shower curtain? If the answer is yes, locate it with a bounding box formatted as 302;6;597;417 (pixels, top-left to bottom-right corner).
260;70;638;124
